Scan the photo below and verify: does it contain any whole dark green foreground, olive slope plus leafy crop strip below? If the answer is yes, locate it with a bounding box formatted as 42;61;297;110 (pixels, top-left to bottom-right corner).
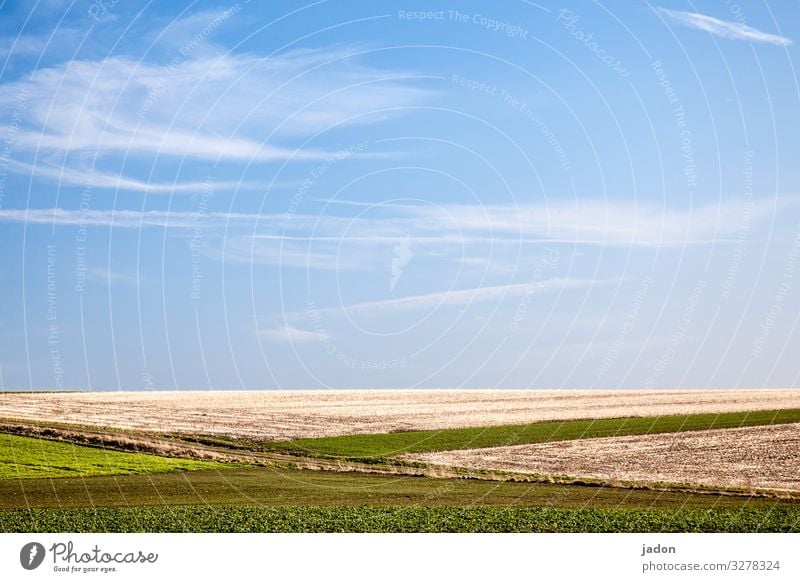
0;468;800;532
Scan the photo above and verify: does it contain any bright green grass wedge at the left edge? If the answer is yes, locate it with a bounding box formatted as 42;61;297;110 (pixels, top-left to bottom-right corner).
0;434;224;480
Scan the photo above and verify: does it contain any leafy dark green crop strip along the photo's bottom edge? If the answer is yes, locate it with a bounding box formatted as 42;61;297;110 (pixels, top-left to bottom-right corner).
0;506;800;533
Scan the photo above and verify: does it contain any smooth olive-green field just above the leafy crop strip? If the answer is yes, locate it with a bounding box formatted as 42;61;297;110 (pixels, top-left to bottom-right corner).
0;467;800;509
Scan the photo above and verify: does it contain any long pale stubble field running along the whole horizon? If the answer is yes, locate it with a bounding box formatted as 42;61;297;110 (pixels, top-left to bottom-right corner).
0;390;800;440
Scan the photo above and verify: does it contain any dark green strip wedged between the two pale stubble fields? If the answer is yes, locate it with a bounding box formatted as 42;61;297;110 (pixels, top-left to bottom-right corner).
267;408;800;461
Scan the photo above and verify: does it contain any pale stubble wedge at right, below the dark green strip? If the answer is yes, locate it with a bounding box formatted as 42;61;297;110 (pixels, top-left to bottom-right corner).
406;424;800;491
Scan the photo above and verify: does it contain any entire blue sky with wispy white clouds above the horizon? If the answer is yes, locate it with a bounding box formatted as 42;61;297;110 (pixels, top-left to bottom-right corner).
0;0;800;390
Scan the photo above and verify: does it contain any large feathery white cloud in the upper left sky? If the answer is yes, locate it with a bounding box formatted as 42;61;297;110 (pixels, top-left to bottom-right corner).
0;46;433;162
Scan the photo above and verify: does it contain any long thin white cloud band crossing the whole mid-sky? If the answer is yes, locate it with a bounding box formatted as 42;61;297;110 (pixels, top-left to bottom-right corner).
0;196;800;245
